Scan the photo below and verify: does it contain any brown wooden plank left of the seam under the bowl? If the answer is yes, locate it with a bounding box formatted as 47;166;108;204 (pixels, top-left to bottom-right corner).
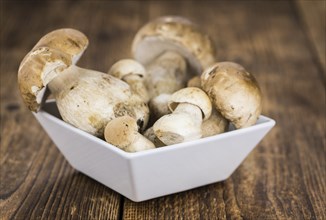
0;1;148;219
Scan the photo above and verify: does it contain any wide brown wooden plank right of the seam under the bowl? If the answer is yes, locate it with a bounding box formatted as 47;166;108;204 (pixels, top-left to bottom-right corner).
123;1;326;219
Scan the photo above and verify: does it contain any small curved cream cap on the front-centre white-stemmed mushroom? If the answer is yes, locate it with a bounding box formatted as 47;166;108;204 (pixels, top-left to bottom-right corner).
168;87;212;120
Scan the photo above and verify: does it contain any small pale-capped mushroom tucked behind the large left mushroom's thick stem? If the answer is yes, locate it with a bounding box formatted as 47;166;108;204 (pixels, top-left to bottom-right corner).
108;59;149;103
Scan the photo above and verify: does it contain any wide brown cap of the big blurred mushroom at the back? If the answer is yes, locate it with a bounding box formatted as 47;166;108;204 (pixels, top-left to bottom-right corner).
132;16;215;74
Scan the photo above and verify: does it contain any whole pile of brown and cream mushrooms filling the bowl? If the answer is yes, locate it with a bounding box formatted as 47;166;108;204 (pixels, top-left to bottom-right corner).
18;16;262;152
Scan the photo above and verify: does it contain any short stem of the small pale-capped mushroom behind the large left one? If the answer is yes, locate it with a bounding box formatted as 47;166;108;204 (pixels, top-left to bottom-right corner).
122;74;149;103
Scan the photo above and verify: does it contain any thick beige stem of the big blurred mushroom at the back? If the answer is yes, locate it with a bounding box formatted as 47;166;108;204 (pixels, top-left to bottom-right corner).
146;51;186;118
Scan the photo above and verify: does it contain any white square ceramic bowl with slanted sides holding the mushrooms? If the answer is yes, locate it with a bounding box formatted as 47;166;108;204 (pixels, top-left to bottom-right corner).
34;101;275;202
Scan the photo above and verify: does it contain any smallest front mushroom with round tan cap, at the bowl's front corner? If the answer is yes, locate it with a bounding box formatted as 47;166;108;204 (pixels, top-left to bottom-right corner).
104;115;155;152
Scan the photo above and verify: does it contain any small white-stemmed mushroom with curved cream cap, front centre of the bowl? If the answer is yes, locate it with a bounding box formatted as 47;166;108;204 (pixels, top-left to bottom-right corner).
153;87;212;145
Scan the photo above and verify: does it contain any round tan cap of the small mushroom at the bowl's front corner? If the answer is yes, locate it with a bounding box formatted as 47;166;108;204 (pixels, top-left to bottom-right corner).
104;115;138;149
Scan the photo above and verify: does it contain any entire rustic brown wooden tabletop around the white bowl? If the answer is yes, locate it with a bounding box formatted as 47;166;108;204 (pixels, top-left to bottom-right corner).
0;0;326;219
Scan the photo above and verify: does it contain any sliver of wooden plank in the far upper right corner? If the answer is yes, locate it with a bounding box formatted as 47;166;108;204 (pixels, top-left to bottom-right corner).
295;0;326;73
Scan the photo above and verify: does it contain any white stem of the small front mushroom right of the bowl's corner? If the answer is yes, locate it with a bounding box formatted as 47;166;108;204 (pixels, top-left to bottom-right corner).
153;103;203;145
